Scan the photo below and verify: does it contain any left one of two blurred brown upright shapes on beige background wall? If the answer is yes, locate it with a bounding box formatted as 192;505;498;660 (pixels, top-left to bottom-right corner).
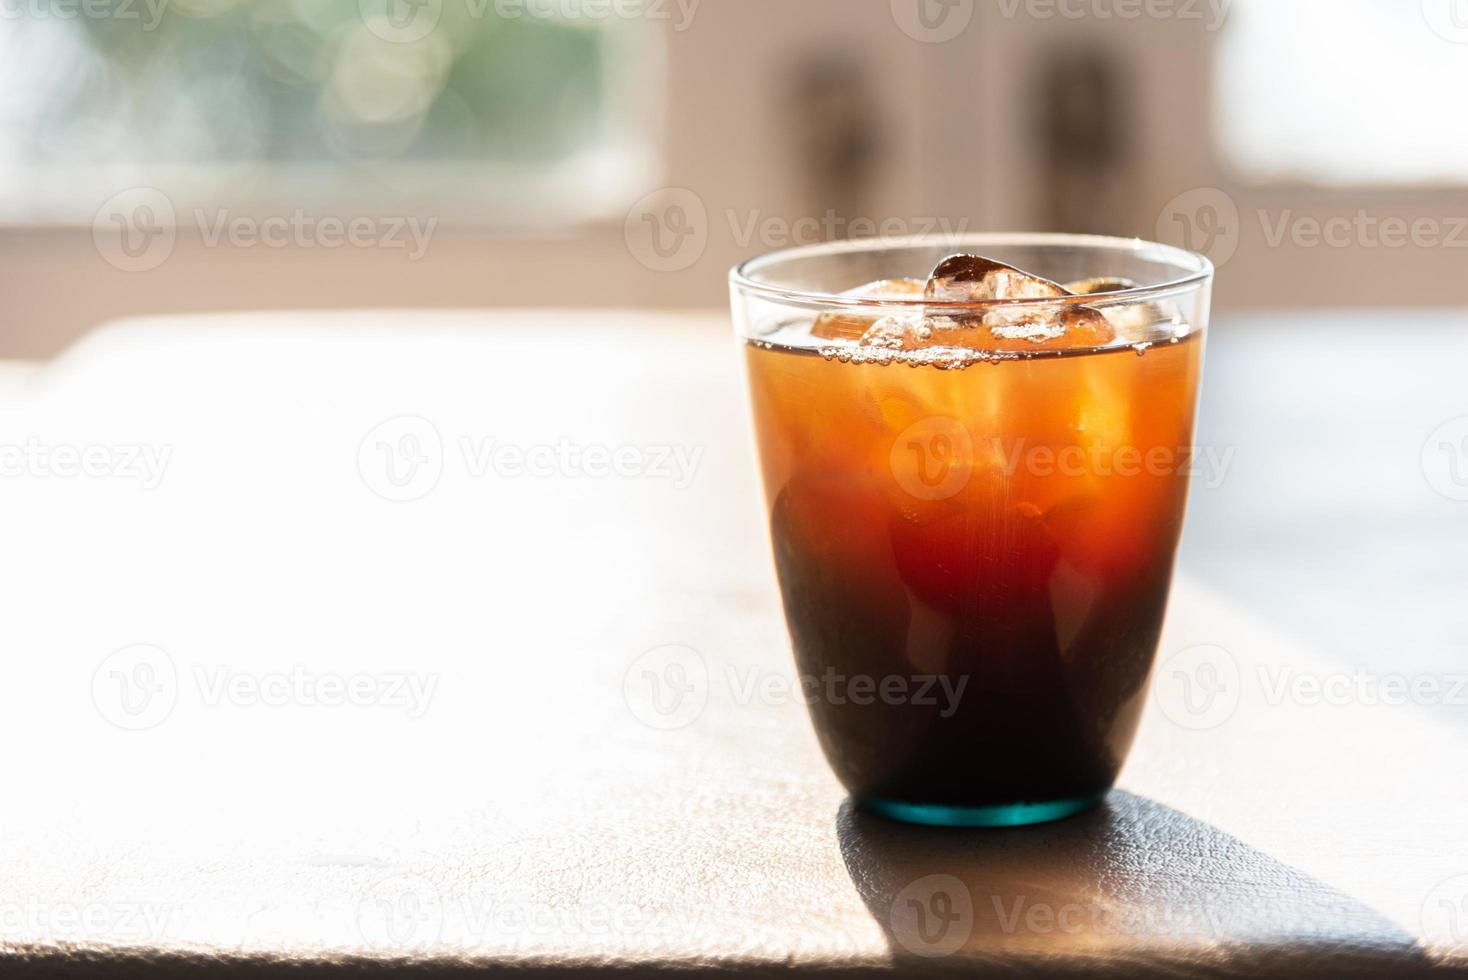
785;56;882;238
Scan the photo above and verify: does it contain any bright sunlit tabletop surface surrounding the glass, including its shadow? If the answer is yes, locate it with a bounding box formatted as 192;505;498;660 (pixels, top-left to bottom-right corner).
0;311;1468;976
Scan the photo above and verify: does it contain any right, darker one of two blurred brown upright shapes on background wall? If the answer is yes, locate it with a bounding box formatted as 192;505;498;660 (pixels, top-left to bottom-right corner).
1033;48;1144;235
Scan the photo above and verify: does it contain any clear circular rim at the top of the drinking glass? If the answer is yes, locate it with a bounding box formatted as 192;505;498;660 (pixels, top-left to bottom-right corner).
728;232;1214;312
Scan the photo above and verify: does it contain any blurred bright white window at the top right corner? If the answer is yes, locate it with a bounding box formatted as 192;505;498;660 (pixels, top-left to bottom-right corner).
1217;0;1468;185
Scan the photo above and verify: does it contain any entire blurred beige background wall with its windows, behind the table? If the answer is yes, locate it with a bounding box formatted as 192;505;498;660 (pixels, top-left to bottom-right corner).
0;0;1468;356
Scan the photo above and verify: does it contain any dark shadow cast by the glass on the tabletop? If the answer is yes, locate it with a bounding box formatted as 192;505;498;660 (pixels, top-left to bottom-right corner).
837;791;1433;977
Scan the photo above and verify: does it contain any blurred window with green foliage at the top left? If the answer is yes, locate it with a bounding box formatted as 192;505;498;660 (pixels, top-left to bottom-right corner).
0;0;655;226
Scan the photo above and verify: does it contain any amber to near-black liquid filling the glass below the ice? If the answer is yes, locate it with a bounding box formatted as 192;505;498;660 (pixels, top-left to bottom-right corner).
746;333;1202;805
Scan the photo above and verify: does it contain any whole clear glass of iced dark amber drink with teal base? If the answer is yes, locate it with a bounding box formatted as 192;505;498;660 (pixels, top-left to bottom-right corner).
733;236;1211;826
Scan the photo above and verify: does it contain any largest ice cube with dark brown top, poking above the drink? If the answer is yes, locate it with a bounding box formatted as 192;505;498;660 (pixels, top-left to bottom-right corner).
925;254;1116;351
